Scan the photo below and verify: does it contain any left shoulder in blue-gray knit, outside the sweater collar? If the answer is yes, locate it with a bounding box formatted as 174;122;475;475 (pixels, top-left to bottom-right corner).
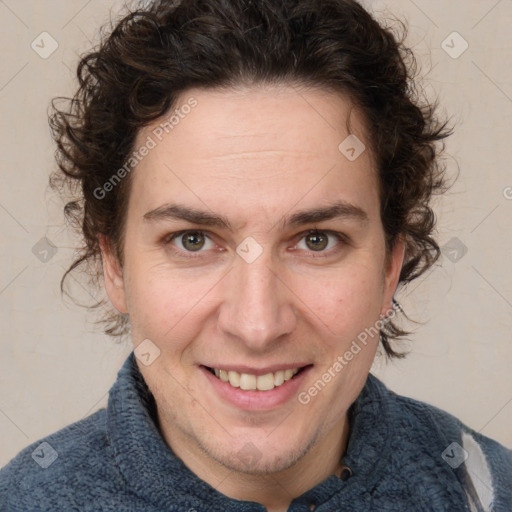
0;409;127;511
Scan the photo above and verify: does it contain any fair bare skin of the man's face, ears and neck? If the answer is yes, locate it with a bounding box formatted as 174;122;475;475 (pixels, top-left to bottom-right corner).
101;85;404;512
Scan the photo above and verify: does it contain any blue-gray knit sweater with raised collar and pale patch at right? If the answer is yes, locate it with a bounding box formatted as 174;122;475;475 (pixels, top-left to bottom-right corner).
0;352;512;512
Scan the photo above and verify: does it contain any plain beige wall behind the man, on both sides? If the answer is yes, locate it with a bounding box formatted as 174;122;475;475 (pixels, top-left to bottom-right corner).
0;0;512;466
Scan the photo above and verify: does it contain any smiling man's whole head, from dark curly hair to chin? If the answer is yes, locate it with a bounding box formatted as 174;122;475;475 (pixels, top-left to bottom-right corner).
52;0;448;472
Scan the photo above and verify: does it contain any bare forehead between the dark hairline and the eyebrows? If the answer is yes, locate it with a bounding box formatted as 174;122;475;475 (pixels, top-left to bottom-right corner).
127;86;378;224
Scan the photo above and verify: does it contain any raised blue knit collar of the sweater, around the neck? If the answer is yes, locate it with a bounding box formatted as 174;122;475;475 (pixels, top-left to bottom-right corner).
106;352;391;512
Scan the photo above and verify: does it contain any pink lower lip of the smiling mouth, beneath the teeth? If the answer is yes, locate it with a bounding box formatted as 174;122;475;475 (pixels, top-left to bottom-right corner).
199;366;312;411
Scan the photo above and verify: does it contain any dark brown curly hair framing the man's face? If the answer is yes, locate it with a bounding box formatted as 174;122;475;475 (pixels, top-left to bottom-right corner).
50;0;451;357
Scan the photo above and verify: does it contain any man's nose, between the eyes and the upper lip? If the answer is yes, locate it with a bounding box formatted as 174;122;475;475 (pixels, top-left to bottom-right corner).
218;253;297;352
